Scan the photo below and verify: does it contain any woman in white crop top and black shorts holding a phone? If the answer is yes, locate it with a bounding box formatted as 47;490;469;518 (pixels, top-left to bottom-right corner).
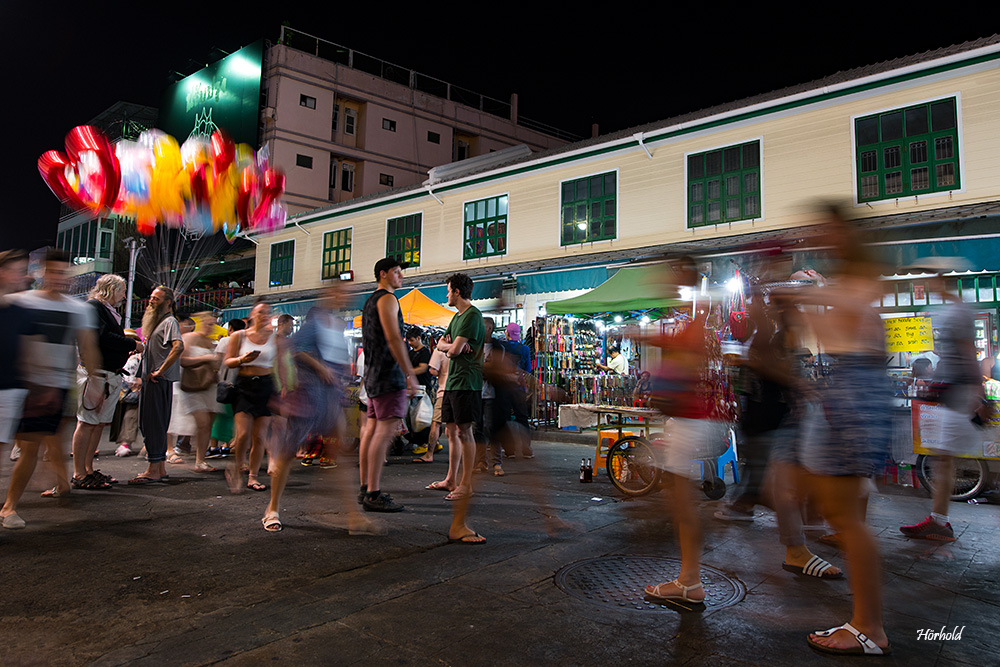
224;303;278;493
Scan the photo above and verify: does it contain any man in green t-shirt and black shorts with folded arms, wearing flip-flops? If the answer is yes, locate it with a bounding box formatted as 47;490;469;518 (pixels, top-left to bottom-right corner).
437;273;486;544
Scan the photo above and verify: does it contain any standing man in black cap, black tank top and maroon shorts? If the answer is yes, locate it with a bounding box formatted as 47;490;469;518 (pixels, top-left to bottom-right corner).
358;257;419;512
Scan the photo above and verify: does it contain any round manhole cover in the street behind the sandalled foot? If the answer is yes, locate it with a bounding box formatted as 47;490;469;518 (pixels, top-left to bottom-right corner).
556;556;747;612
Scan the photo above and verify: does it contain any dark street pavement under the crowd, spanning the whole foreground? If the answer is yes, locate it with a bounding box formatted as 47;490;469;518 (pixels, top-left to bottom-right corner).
0;442;1000;667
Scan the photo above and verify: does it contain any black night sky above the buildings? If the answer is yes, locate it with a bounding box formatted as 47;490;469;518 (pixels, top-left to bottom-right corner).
0;2;984;250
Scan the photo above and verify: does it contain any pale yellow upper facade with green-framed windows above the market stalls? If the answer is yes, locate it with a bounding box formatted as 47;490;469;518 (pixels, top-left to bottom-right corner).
246;38;1000;314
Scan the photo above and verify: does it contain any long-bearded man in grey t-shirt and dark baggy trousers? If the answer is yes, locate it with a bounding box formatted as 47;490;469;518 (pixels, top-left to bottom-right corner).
129;285;184;485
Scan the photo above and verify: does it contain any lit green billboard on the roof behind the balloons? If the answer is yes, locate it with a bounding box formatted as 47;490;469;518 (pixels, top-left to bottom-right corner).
157;40;264;148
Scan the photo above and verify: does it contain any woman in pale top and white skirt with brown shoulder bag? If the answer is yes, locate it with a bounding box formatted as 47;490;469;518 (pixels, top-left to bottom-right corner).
181;312;219;472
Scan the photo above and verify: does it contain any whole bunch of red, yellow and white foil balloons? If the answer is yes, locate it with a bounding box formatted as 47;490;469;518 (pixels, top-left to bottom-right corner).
38;125;288;241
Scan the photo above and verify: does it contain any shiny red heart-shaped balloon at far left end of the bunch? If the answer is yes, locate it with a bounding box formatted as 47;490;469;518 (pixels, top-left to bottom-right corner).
38;125;121;212
